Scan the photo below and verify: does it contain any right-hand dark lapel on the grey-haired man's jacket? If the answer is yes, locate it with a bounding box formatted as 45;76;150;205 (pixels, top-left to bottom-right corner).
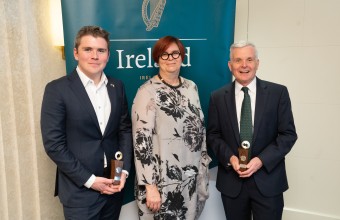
253;78;268;142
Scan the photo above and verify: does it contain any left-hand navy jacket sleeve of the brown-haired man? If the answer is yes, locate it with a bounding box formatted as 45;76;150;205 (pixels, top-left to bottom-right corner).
40;81;92;187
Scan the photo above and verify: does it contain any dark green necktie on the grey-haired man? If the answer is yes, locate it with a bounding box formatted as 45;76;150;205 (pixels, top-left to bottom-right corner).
240;87;253;154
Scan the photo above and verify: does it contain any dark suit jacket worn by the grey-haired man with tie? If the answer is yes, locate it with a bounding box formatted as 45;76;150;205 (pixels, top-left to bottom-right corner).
207;78;297;197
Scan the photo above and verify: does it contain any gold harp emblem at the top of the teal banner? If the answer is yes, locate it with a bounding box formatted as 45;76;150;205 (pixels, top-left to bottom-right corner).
142;0;166;31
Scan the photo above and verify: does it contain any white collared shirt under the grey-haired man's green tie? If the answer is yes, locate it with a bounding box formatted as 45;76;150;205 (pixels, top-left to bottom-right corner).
235;77;256;130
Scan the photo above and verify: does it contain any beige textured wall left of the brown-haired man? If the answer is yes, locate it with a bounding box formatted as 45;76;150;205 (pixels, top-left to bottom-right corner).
0;0;65;220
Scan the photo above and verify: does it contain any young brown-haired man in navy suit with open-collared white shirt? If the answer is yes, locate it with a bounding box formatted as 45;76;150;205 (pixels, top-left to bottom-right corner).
41;26;132;220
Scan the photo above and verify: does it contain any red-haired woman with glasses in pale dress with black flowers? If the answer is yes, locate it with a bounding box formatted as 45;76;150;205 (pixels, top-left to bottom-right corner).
132;36;211;220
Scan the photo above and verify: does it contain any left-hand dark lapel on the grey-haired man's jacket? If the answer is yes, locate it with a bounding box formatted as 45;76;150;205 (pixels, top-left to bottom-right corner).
224;81;240;143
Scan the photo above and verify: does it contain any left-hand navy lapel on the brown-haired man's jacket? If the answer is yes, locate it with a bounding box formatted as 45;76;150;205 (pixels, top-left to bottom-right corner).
69;70;101;133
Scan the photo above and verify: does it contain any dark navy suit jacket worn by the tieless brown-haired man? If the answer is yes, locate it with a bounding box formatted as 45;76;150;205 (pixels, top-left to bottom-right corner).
41;70;132;207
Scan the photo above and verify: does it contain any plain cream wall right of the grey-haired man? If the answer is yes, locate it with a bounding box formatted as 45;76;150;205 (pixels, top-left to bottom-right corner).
235;0;340;220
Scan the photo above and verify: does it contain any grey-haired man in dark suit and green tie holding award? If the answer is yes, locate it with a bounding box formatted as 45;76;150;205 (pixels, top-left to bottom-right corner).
207;42;297;220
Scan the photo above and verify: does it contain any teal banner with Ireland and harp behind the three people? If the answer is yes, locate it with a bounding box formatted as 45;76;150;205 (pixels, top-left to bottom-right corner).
61;0;236;202
